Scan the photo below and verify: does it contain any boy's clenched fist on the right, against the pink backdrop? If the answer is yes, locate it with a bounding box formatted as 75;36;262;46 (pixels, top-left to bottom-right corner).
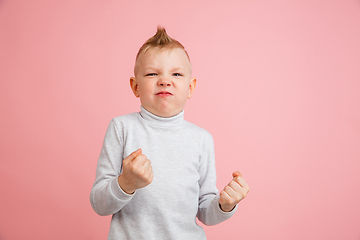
219;171;250;212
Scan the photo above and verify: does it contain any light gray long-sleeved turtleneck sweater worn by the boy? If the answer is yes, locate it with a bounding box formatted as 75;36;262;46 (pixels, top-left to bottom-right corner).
90;107;236;240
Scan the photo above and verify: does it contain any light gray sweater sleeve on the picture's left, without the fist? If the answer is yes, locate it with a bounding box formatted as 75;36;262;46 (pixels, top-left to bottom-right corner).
90;120;135;216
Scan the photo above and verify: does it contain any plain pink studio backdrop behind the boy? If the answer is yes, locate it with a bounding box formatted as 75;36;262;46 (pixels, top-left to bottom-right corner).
0;0;360;240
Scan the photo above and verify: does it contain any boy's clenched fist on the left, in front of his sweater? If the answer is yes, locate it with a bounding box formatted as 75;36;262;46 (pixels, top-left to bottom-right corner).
118;148;154;194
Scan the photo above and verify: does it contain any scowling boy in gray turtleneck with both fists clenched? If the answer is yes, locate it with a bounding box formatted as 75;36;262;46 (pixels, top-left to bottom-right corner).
90;27;249;240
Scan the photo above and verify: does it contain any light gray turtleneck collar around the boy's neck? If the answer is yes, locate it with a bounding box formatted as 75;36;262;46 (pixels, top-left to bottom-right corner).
140;106;184;127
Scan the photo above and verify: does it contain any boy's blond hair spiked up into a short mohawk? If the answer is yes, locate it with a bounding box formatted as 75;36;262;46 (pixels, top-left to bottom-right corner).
134;26;190;72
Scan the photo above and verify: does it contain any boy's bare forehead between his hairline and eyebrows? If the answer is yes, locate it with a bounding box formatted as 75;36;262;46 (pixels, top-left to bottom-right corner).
136;48;191;71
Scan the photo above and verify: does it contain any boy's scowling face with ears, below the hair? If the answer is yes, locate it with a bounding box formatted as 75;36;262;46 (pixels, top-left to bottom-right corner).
130;48;196;117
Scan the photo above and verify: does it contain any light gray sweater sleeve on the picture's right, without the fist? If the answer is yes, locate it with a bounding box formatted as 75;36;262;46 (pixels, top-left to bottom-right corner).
197;134;237;225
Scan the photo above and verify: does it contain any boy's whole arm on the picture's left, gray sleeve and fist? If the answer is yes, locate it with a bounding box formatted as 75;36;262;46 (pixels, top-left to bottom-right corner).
90;120;153;216
